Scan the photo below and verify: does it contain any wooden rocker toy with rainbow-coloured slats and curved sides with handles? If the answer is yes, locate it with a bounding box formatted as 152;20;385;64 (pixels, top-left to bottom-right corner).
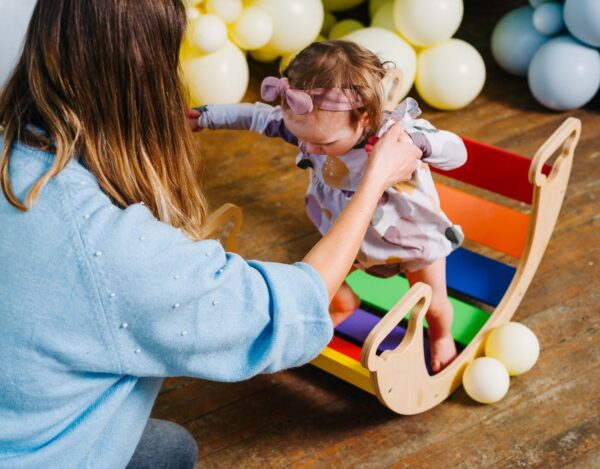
206;117;581;415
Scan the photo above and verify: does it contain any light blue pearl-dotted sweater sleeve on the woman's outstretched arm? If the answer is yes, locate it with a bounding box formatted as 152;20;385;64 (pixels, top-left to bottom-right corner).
73;190;333;381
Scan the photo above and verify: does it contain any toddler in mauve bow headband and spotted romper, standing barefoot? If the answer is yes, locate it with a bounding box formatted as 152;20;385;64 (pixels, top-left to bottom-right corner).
191;40;467;373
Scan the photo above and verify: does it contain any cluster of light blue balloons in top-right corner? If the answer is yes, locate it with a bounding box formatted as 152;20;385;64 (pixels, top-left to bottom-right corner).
492;0;600;111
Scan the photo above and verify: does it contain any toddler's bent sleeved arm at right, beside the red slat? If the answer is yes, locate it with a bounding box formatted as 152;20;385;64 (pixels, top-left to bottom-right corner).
402;119;467;170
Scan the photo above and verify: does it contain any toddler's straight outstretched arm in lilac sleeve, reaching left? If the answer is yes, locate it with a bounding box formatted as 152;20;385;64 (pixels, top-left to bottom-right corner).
196;103;298;145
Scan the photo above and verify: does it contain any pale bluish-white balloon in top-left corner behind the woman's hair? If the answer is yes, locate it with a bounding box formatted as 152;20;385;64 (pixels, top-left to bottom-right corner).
0;0;36;88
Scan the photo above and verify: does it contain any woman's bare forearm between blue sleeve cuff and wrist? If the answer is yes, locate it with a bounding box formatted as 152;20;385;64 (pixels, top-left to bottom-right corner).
303;178;383;300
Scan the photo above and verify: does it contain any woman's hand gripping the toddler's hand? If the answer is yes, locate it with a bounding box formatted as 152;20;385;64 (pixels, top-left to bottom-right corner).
364;124;423;192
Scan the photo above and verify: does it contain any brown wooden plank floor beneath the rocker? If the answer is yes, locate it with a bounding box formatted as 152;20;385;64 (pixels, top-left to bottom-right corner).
153;0;600;468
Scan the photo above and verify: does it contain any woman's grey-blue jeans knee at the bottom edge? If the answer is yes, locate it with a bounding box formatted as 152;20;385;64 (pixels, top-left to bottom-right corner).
127;419;198;469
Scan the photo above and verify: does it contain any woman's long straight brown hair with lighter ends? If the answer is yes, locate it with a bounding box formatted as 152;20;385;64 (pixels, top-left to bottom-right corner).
0;0;206;239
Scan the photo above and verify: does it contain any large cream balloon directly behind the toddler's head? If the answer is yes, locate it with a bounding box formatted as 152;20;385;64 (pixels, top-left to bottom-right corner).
343;27;417;99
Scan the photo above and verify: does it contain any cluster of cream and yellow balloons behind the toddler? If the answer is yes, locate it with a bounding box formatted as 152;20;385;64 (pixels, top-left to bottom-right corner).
181;0;485;110
